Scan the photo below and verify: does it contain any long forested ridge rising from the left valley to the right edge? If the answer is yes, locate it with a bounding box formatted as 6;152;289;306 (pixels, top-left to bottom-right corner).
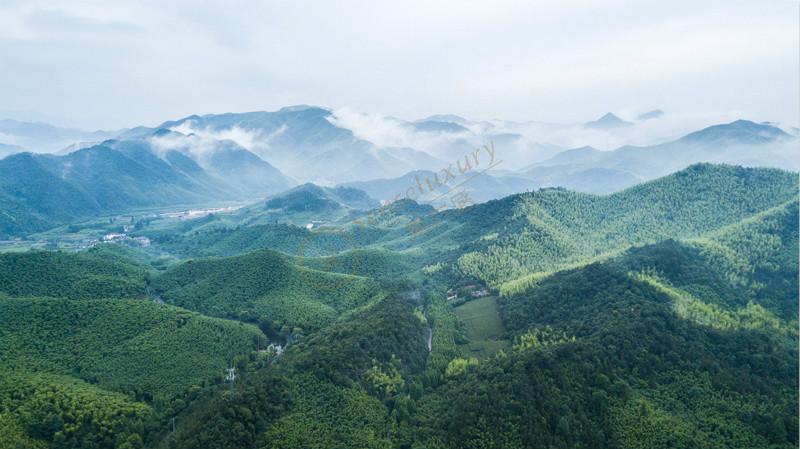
130;164;798;287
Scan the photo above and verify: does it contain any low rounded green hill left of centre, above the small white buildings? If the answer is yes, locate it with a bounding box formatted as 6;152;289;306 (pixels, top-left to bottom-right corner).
152;250;376;333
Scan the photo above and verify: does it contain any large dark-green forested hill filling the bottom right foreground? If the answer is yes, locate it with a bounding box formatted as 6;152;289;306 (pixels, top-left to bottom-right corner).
409;236;798;448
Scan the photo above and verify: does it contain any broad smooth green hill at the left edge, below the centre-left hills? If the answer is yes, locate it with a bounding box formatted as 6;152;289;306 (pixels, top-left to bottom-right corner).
0;298;265;403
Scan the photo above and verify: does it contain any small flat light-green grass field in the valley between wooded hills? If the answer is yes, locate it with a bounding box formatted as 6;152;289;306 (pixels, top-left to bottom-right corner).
455;296;510;357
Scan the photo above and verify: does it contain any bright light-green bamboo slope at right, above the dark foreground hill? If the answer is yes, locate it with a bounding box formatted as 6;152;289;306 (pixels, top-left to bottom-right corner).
458;164;798;285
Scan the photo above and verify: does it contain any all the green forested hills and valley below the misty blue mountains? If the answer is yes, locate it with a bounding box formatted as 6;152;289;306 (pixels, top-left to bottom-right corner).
0;162;799;449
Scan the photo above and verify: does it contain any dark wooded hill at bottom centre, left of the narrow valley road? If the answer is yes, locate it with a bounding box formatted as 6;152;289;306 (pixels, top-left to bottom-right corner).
161;298;426;449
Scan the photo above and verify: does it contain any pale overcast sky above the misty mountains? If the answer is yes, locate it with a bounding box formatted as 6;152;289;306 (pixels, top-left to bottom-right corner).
0;0;800;129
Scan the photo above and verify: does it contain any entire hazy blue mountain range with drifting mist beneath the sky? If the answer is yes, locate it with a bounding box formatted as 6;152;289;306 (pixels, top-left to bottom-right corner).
0;106;800;237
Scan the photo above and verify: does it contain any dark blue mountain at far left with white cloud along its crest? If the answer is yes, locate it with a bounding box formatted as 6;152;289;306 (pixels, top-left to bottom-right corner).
0;132;293;236
